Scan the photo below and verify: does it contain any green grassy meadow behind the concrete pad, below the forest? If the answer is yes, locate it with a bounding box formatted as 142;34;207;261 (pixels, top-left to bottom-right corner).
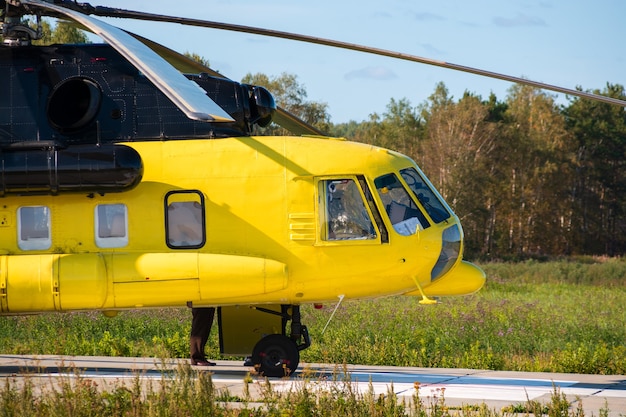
0;259;626;374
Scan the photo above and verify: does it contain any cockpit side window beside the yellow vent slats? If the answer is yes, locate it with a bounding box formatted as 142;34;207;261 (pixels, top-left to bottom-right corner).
320;179;377;241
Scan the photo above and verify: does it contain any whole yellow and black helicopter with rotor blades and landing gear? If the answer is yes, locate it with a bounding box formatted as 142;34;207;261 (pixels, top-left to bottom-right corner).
0;0;626;376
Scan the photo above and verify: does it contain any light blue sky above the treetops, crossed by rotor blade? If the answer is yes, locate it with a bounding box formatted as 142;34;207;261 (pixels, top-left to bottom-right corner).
91;0;626;123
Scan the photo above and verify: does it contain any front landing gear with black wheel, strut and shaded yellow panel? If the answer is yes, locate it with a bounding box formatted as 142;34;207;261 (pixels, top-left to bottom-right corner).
217;304;311;377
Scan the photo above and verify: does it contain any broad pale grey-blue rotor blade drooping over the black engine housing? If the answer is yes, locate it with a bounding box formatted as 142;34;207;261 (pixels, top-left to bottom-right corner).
20;0;233;122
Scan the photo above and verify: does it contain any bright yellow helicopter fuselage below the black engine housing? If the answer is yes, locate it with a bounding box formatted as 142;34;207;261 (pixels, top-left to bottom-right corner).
0;137;484;314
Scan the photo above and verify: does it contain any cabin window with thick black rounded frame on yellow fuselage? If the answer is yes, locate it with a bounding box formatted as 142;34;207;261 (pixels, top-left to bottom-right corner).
165;191;206;249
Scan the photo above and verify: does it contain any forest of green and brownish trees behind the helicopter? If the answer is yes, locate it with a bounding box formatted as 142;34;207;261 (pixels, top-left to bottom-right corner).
12;23;626;259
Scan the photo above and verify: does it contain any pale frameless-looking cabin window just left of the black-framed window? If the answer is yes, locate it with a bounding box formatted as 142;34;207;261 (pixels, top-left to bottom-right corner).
94;204;128;248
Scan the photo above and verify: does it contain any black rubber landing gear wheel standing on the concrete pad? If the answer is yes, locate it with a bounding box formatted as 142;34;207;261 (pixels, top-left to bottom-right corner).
252;334;300;377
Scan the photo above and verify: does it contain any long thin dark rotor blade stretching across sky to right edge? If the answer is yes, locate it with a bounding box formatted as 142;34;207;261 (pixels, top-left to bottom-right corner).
90;6;626;107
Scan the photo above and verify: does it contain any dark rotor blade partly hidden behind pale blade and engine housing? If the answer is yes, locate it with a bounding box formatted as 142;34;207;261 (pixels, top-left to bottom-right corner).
127;32;324;136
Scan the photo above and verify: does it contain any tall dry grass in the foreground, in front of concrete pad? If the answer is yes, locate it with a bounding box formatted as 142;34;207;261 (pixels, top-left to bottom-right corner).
0;365;609;417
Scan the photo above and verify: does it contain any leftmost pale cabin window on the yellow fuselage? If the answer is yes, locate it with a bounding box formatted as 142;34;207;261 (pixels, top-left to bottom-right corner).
17;206;52;250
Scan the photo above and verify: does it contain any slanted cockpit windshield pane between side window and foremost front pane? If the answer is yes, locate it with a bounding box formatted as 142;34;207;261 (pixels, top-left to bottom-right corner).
374;174;430;236
